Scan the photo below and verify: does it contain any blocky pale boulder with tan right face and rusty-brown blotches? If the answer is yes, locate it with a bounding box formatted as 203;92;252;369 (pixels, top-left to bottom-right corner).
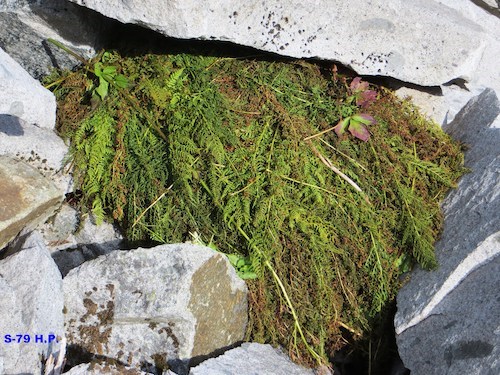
63;244;247;372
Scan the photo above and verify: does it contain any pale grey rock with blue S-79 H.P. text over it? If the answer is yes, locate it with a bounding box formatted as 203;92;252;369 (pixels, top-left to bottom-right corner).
0;232;64;374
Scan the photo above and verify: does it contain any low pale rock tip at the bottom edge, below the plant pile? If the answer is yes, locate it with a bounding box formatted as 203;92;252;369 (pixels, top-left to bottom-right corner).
189;343;315;375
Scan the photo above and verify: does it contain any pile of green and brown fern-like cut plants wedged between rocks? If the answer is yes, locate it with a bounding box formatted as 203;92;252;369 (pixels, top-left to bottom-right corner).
47;48;463;372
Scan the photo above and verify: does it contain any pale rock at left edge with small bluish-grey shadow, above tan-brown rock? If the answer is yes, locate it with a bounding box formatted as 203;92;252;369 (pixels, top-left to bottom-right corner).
0;46;72;193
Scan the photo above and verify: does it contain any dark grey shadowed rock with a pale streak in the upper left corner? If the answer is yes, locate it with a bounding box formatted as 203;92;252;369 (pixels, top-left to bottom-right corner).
0;0;97;79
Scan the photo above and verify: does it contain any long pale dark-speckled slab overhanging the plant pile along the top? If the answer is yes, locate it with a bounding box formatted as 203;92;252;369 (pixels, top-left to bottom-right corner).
71;0;487;85
